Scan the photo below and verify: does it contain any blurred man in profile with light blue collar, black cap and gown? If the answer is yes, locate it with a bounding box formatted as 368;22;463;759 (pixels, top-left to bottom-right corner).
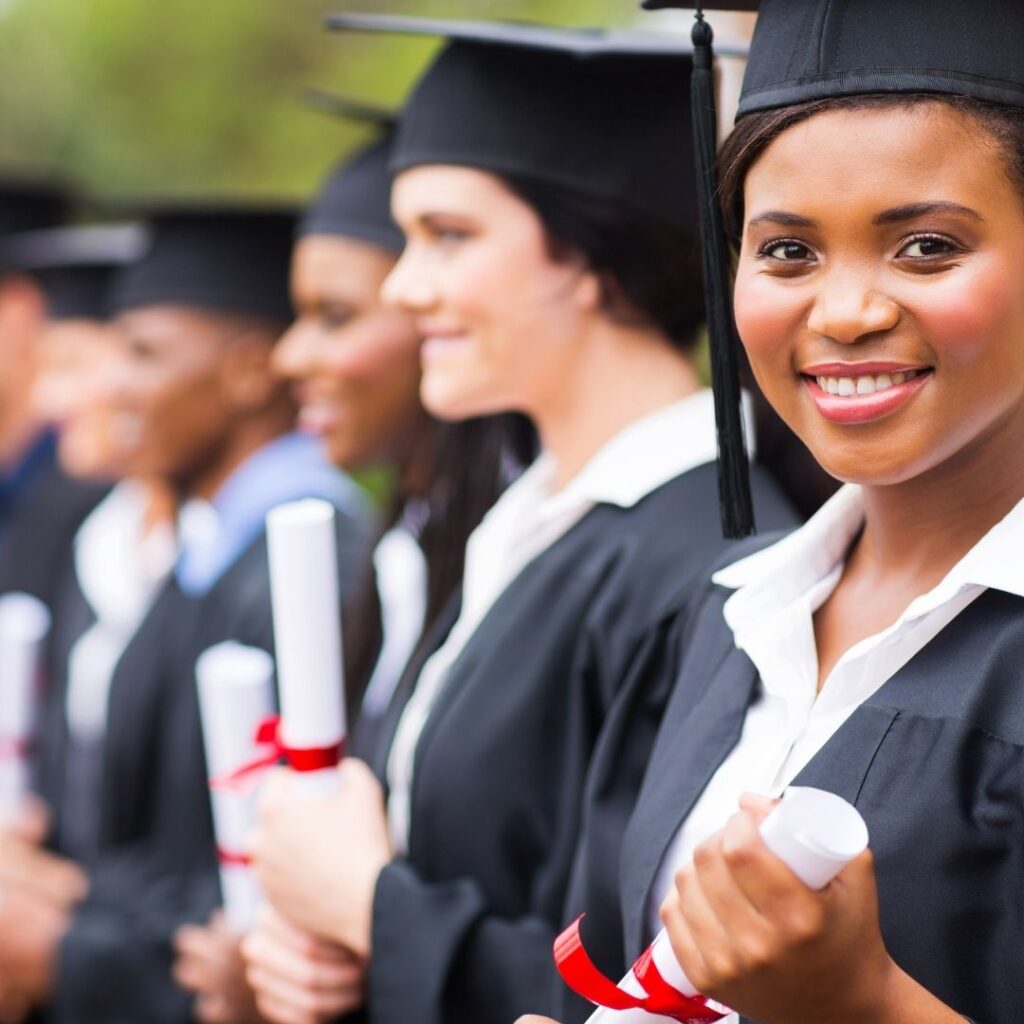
0;207;366;1022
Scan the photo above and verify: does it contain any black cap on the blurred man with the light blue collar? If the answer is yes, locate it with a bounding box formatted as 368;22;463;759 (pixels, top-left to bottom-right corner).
113;206;295;321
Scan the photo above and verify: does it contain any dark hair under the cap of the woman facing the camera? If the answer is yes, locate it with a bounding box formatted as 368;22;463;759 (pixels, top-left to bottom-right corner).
718;92;1024;242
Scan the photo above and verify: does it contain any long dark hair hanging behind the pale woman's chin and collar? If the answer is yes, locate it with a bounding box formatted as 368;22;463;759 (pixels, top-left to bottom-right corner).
343;414;538;721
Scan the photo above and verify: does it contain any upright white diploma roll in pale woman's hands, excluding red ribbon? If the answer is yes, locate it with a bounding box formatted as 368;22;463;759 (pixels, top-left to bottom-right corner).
266;498;346;797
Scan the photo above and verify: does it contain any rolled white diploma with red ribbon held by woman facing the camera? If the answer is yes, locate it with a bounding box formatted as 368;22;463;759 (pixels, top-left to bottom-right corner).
555;786;868;1024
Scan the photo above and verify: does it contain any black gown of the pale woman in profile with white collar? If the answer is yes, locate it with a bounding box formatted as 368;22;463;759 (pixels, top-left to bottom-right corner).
360;465;796;1024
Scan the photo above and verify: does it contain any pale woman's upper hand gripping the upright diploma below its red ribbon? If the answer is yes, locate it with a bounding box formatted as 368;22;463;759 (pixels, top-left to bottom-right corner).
250;759;392;958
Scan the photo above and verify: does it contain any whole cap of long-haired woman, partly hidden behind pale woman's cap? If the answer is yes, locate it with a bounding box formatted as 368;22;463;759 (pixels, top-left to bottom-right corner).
299;89;406;253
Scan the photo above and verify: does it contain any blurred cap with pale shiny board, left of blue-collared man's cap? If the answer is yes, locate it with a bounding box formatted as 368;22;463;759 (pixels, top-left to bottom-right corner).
0;224;145;321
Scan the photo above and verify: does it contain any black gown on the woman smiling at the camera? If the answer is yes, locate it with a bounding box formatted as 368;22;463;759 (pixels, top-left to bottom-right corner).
557;553;1024;1024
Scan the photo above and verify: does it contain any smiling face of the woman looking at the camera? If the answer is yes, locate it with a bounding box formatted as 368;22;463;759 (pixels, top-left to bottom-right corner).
735;102;1024;484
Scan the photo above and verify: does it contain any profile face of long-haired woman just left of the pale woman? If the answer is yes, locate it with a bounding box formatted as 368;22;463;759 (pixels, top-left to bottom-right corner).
273;234;426;469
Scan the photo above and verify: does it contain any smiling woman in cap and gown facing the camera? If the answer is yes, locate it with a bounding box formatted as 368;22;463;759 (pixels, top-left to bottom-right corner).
524;0;1024;1024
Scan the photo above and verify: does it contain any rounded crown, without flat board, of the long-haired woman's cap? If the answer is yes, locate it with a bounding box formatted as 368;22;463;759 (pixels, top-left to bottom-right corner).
299;135;406;253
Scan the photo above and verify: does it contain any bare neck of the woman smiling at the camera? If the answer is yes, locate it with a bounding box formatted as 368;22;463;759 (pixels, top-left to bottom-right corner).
854;411;1024;588
